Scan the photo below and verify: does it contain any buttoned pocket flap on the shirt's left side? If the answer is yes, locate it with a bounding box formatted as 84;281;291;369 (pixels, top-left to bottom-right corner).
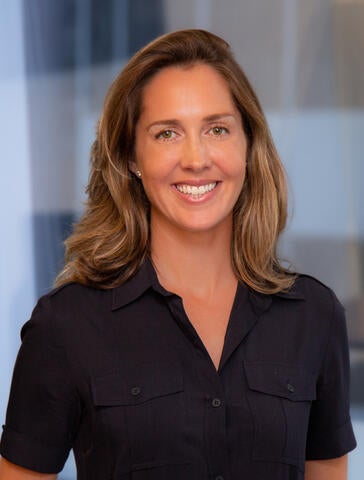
92;363;183;406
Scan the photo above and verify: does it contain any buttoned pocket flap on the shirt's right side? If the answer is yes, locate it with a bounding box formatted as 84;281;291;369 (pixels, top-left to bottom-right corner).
244;361;316;402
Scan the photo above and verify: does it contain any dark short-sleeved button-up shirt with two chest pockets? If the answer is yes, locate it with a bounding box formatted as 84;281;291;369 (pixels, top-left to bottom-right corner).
0;261;355;480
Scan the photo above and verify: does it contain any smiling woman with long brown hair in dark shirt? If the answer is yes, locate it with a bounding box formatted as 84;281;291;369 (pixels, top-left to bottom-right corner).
0;30;355;480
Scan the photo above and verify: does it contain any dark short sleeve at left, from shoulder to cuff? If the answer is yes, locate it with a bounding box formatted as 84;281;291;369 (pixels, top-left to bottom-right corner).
0;297;80;473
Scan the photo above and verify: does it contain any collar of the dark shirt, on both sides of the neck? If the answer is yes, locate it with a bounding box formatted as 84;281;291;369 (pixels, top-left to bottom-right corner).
111;257;305;314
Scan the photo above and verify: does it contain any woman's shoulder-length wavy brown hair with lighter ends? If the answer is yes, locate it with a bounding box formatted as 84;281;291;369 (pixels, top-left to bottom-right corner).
56;30;295;294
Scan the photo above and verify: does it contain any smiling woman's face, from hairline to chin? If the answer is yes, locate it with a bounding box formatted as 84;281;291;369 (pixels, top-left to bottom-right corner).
130;65;247;236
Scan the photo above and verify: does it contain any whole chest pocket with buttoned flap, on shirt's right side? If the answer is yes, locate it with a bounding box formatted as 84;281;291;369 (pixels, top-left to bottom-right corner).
244;361;316;471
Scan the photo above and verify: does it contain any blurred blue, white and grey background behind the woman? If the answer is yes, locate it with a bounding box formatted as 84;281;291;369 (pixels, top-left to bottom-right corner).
0;0;364;480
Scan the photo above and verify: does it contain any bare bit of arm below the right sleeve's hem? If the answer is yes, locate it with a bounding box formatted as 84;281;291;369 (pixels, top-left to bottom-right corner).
306;455;348;480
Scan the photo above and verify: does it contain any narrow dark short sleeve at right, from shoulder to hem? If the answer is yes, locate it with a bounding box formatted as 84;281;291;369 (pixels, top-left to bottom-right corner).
306;292;356;460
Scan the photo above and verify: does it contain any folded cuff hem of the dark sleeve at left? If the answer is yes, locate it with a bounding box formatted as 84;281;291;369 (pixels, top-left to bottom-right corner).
0;426;70;474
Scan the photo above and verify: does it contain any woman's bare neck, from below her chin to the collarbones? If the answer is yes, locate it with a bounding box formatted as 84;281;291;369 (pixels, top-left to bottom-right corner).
151;216;237;299
